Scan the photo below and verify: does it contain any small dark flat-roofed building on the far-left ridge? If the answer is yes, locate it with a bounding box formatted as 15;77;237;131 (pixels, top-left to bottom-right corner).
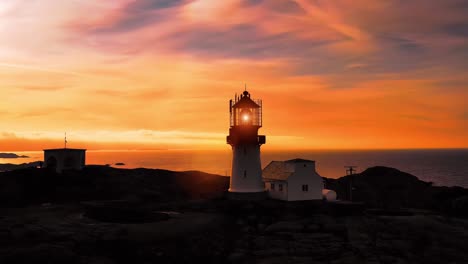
44;148;86;173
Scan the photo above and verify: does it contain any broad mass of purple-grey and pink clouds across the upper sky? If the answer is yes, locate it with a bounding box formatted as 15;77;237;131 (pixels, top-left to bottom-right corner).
66;0;468;81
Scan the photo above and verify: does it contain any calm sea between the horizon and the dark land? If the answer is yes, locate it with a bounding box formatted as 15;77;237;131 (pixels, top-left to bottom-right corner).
0;149;468;188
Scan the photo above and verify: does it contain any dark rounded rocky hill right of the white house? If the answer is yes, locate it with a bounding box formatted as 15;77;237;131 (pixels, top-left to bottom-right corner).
325;167;468;215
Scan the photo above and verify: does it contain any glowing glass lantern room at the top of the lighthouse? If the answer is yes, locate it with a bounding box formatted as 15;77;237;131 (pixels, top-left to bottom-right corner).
229;91;262;128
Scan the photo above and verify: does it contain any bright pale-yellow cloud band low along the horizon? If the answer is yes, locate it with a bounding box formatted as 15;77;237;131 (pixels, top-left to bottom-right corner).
0;129;304;151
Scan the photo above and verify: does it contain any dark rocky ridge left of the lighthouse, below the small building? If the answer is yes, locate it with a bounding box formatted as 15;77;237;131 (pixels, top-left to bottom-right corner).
0;166;229;206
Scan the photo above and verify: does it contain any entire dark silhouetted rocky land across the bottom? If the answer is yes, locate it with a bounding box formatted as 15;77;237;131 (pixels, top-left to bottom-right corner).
0;166;468;263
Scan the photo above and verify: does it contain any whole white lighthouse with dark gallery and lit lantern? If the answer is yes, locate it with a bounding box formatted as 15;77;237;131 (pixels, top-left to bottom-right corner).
226;90;266;196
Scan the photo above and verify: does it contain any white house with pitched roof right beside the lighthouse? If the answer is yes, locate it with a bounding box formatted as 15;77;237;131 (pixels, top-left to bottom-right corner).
263;159;323;201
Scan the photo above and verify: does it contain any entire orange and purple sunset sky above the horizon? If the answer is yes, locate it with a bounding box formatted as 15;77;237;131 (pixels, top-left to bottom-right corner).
0;0;468;151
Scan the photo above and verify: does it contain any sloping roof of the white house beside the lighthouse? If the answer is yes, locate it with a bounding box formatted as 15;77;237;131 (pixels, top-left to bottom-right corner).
262;159;315;181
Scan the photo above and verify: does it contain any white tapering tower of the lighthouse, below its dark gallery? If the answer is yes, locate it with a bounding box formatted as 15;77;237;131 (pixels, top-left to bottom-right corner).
229;145;265;192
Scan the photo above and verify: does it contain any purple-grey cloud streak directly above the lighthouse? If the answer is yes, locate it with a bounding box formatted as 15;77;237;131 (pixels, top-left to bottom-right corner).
167;24;347;59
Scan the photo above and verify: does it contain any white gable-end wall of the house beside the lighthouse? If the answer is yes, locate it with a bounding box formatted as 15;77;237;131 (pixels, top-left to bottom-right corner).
288;162;323;201
